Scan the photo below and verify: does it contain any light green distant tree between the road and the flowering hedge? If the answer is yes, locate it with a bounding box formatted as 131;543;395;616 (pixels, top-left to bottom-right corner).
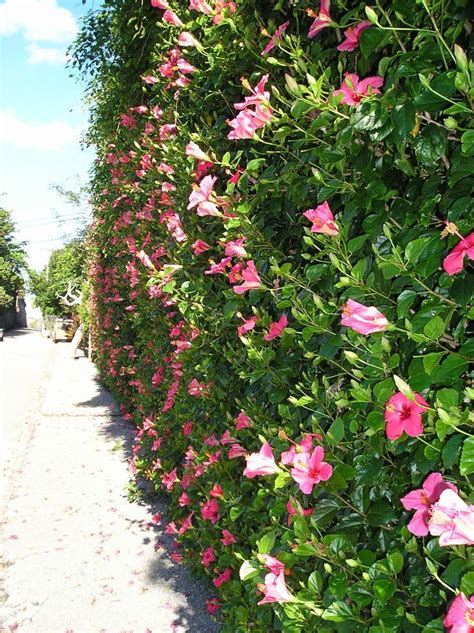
30;238;85;317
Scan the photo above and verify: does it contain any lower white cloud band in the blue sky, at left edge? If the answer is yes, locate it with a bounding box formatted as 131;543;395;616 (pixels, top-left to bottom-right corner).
0;110;79;150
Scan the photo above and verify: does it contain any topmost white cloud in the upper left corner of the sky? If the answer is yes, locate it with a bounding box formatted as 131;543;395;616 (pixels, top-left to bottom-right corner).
0;0;77;42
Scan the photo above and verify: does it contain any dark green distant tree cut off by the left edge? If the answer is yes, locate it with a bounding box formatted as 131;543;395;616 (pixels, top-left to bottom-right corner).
0;208;27;312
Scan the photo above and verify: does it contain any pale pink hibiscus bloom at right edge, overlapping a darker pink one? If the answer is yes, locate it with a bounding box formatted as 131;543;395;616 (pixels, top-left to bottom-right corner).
428;489;474;546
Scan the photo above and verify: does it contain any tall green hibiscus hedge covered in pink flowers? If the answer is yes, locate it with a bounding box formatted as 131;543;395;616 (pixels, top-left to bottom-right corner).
72;0;474;633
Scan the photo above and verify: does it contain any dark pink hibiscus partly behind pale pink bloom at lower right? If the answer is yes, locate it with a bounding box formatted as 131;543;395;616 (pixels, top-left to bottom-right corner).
400;473;458;536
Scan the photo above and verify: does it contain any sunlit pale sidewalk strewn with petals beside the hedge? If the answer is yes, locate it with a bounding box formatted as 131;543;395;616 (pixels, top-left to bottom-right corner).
0;344;219;633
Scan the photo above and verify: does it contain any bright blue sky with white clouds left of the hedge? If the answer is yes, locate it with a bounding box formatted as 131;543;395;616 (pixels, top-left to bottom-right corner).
0;0;99;269
